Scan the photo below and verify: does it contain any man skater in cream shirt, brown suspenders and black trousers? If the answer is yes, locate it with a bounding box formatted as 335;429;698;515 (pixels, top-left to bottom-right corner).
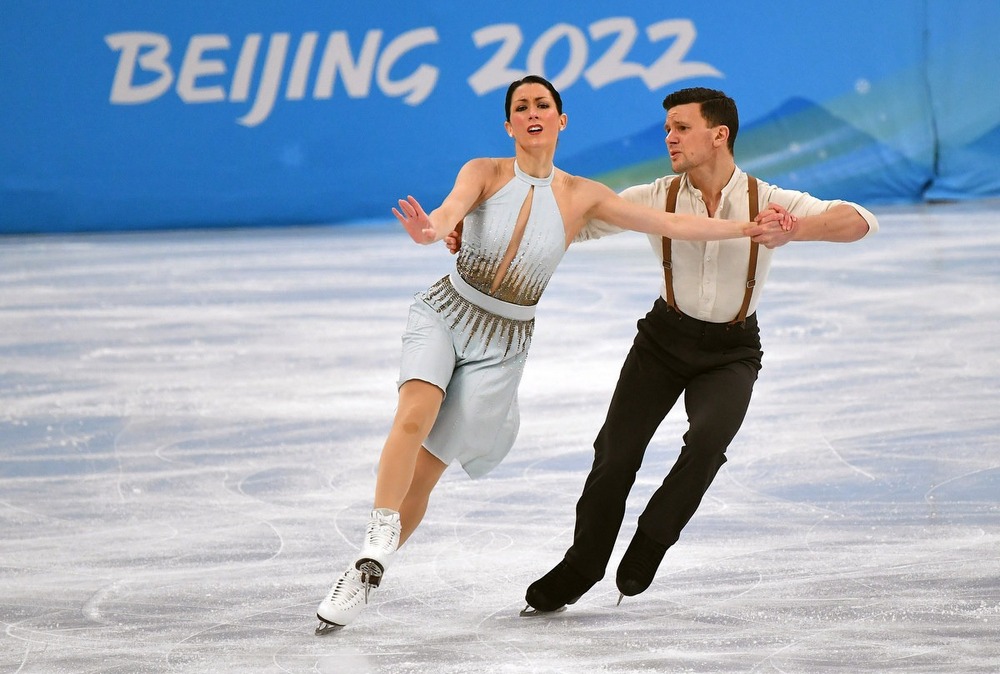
525;88;878;613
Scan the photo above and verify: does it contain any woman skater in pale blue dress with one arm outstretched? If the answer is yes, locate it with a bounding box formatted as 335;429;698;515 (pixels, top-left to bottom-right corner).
316;75;790;634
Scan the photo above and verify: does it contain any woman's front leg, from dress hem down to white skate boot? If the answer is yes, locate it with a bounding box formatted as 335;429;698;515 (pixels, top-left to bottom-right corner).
374;379;444;510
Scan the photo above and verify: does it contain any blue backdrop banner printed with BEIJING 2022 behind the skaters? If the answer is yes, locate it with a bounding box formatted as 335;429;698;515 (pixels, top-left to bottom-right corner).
0;0;1000;233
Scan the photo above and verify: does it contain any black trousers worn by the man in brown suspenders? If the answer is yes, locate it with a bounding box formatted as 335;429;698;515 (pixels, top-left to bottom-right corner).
566;298;763;581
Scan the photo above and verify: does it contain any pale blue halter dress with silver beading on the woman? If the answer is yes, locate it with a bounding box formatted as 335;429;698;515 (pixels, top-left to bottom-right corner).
399;162;566;478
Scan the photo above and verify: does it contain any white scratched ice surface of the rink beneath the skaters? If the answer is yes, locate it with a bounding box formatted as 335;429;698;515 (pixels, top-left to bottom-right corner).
0;202;1000;674
